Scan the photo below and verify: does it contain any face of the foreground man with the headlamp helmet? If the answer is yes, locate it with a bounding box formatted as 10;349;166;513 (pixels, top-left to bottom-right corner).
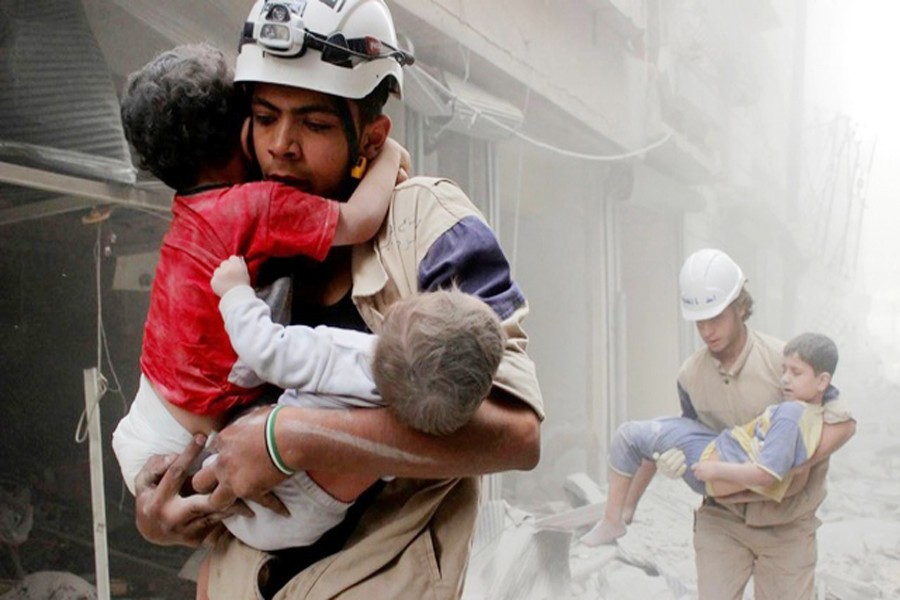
251;83;356;199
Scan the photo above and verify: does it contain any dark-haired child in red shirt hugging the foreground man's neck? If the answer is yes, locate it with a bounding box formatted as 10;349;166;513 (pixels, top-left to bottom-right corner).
113;44;408;493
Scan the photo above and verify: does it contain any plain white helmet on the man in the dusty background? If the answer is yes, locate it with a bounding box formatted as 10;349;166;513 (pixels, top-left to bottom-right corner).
678;248;747;321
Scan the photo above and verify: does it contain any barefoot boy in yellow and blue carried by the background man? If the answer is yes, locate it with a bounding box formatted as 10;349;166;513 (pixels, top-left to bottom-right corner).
581;333;849;546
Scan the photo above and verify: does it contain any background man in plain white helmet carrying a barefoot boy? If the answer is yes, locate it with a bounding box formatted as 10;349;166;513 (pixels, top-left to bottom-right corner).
668;249;856;600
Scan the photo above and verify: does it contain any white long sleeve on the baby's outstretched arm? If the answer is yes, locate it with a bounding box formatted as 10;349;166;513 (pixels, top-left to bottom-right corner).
219;286;380;400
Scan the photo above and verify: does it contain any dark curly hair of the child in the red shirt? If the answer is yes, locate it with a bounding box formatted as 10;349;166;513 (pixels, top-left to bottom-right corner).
121;44;249;191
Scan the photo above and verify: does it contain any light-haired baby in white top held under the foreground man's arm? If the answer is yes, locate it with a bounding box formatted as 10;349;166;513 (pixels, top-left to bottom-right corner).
207;256;505;550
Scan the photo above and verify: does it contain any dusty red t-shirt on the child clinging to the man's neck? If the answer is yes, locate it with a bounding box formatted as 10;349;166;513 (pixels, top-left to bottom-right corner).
141;182;340;415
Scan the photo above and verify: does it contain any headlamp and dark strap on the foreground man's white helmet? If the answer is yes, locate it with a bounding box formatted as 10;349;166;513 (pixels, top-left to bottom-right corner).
241;1;415;68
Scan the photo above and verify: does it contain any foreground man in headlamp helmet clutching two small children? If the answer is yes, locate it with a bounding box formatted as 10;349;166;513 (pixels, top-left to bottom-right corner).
130;0;543;599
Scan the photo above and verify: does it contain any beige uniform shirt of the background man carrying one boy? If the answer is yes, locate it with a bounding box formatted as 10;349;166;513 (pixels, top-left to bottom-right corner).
678;328;850;527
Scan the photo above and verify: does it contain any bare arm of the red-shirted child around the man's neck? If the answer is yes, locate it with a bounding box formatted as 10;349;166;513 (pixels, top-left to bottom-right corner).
333;138;409;246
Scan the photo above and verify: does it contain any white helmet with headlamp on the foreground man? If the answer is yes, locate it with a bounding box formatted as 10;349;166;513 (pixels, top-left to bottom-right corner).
234;0;414;99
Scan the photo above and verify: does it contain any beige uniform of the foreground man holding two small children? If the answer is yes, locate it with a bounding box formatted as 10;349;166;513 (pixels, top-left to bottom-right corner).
209;178;544;600
